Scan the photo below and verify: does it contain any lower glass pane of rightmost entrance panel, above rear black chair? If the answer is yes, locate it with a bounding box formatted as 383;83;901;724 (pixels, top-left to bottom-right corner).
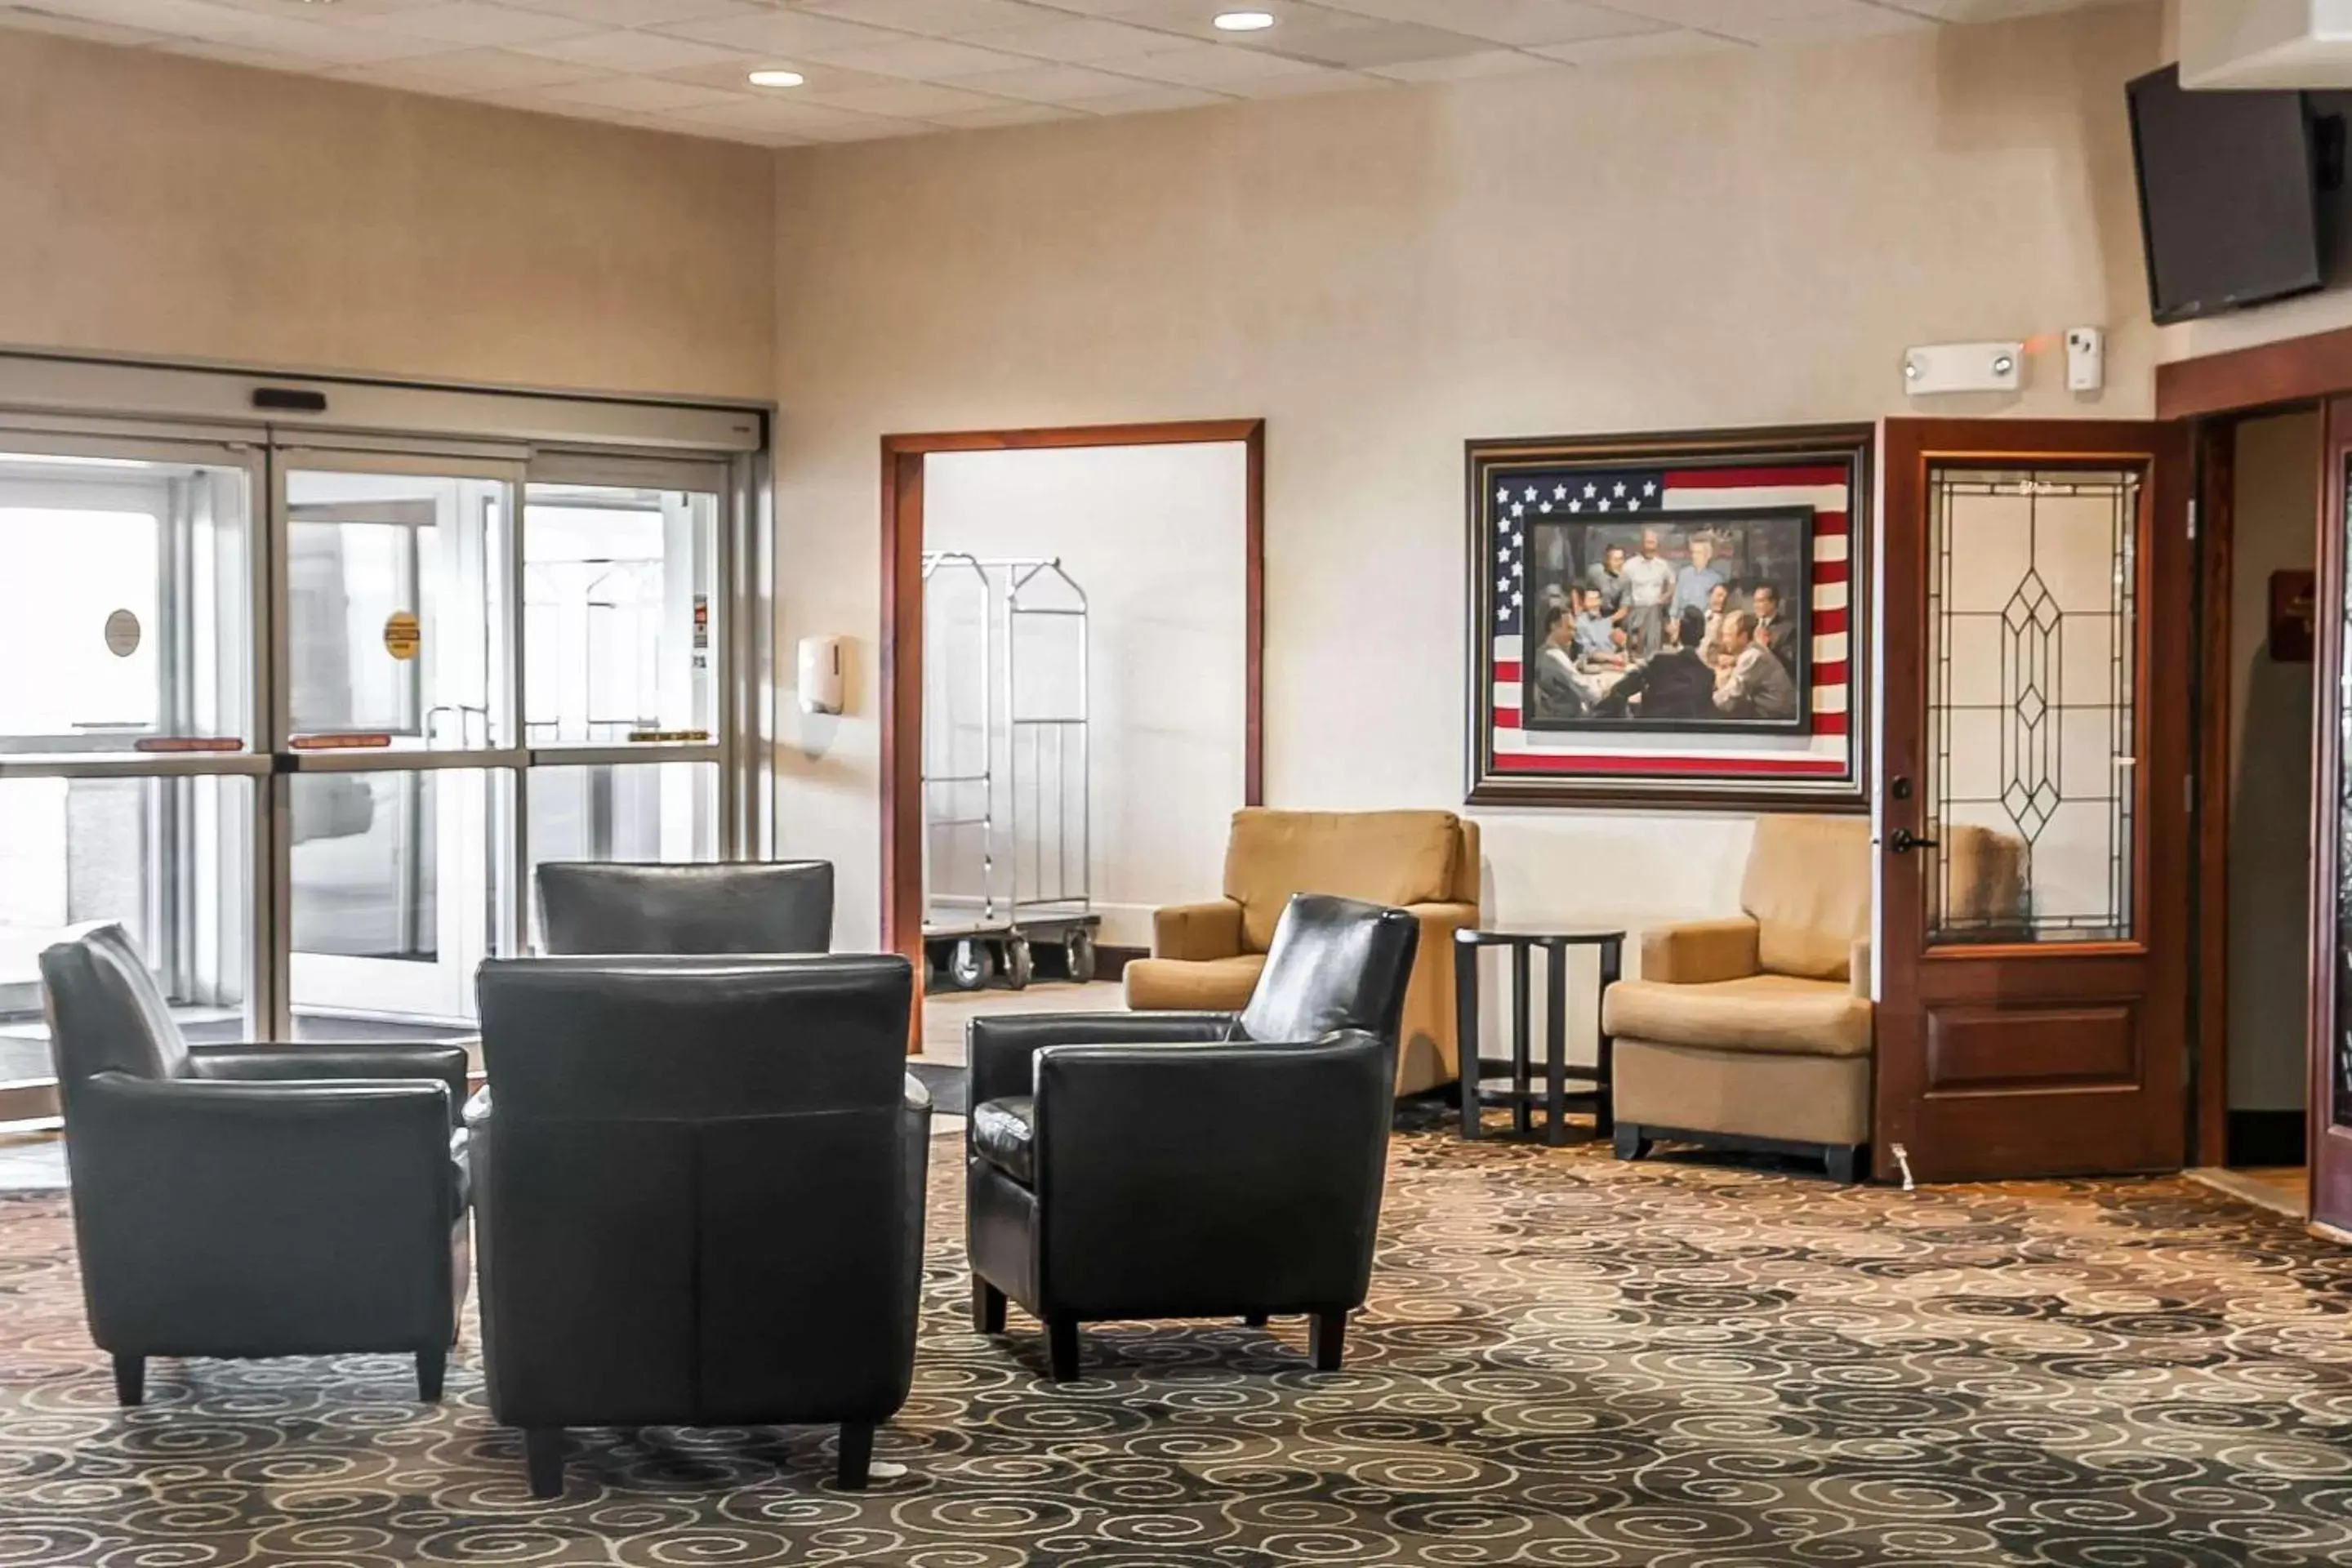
527;762;719;947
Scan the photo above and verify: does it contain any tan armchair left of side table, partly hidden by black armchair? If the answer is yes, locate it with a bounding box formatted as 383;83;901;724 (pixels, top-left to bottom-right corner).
1127;806;1480;1094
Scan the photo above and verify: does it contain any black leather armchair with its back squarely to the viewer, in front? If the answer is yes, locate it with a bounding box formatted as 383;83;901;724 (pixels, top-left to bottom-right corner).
466;957;931;1498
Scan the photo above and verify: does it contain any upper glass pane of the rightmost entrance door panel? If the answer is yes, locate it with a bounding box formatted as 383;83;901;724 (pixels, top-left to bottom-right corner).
522;484;717;746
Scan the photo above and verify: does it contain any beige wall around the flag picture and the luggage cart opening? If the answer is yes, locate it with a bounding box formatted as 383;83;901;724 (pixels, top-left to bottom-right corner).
778;5;2159;940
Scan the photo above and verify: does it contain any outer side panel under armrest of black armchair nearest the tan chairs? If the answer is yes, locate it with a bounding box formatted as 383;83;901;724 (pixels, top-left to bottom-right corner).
1035;1030;1395;1316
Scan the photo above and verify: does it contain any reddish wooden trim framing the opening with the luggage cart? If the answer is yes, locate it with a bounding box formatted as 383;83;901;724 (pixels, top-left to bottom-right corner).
882;418;1265;982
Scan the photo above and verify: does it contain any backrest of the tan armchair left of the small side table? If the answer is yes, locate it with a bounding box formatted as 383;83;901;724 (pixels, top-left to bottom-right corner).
1225;806;1480;952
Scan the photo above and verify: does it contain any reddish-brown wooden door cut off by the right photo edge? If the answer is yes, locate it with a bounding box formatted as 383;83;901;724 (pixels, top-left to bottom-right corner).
2305;397;2352;1232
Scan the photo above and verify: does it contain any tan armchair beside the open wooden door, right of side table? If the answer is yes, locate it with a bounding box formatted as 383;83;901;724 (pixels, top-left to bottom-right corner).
1601;816;1872;1183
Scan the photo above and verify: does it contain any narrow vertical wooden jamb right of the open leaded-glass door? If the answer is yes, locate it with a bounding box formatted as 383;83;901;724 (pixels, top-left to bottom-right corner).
2189;418;2237;1166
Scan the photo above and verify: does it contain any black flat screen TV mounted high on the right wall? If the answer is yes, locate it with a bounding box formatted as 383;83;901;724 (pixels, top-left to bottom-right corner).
2128;66;2326;322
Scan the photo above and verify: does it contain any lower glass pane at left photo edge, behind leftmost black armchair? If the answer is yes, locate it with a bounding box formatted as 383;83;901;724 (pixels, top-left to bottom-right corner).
0;778;254;1081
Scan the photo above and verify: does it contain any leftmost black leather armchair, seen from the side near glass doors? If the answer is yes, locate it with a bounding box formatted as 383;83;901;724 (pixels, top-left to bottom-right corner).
40;926;468;1405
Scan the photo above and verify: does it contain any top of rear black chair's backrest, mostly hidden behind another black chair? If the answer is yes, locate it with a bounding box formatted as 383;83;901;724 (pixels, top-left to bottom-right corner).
539;861;833;955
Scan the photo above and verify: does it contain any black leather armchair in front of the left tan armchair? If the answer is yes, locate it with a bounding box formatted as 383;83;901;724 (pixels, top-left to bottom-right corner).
964;893;1419;1383
